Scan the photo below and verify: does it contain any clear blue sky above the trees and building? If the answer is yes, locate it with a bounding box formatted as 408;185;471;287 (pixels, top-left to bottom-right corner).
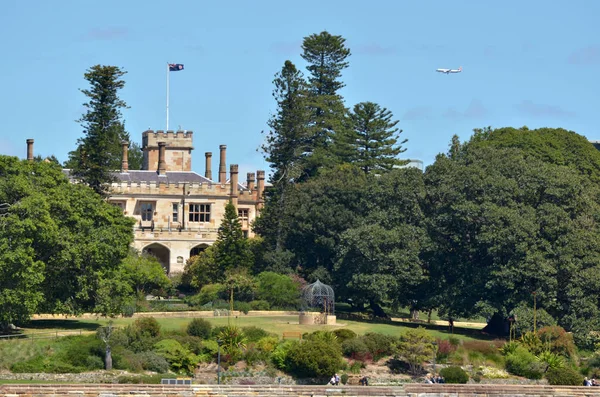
0;0;600;178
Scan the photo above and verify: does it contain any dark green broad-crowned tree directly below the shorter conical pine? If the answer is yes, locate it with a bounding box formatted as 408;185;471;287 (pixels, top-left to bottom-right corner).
334;168;430;316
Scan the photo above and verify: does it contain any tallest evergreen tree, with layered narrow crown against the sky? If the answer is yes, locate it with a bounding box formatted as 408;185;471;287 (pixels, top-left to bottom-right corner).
302;31;350;179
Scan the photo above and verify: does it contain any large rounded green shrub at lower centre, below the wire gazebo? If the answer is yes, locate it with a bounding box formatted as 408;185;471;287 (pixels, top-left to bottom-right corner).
285;340;343;378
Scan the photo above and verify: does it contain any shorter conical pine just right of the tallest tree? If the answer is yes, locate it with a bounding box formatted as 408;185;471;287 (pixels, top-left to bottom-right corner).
345;102;407;174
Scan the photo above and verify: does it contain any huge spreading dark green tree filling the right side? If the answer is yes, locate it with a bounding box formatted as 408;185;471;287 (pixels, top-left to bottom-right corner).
426;134;600;340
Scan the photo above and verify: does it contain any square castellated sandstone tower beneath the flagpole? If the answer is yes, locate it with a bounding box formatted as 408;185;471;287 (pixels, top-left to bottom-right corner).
142;130;194;171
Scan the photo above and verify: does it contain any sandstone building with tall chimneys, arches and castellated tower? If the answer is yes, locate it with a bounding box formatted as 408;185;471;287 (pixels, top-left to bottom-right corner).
27;130;265;274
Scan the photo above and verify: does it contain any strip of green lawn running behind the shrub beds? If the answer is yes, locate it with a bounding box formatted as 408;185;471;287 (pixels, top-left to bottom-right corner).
19;316;487;340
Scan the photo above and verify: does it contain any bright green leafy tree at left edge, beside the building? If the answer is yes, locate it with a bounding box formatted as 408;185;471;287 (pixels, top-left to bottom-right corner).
0;156;133;325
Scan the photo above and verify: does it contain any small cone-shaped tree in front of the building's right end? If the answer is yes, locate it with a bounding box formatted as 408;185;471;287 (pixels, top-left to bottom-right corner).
213;202;252;272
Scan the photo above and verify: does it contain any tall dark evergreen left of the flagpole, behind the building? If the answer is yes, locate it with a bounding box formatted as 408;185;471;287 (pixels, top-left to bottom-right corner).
67;65;129;195
